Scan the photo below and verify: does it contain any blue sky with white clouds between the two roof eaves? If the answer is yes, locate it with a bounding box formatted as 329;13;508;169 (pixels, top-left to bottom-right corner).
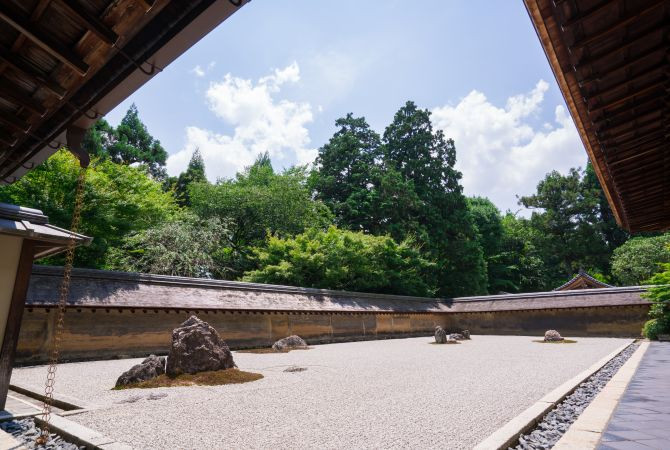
107;0;586;211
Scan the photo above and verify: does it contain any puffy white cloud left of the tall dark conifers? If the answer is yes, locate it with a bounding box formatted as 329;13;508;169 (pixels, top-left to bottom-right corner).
167;62;316;181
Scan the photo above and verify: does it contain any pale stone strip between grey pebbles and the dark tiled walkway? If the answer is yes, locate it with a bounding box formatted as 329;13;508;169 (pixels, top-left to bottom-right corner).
553;342;649;450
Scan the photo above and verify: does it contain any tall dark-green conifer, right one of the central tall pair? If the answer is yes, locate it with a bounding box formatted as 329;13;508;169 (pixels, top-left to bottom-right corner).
376;102;487;296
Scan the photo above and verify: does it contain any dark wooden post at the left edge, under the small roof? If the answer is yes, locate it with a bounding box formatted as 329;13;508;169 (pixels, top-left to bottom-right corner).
0;239;35;410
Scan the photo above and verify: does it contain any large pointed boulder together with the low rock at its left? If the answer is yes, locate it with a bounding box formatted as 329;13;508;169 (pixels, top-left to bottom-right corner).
116;316;237;387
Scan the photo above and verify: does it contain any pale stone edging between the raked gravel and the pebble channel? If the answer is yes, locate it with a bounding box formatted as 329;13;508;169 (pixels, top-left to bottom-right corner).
474;339;637;450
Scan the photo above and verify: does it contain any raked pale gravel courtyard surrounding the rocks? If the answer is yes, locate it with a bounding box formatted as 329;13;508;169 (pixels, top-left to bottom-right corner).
12;336;630;449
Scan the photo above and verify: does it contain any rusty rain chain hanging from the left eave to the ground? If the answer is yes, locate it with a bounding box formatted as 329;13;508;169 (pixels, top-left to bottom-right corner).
35;167;86;445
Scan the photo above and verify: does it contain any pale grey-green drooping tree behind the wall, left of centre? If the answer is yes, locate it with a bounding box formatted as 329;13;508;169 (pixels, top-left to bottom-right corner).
108;213;227;278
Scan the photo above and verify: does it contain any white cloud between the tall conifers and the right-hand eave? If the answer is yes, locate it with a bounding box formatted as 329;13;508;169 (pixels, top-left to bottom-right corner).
432;80;586;211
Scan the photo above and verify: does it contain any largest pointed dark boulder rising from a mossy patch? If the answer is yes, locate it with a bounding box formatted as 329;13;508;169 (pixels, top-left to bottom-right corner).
165;316;237;377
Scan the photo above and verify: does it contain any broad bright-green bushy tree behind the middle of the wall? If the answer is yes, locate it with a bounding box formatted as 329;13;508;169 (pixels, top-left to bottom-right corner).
244;226;434;296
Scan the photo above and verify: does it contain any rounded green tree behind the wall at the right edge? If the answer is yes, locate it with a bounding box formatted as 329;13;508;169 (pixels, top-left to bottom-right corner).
612;233;670;286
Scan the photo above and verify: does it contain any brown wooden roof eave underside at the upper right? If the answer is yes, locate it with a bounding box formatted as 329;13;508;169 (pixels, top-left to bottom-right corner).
525;0;670;232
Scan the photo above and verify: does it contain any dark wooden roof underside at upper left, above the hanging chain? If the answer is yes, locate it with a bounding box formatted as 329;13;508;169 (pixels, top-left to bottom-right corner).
0;0;246;183
